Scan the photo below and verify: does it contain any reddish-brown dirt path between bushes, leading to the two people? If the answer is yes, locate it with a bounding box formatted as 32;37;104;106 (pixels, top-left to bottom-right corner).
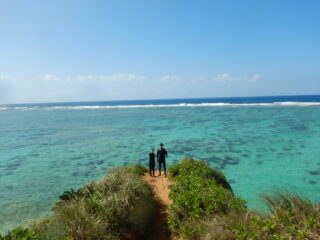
143;171;172;240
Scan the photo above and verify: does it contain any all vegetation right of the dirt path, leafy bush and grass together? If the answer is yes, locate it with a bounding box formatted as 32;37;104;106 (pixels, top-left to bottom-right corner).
168;159;320;240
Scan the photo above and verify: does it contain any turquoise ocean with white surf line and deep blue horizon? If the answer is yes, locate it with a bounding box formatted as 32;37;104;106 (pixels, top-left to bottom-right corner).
0;96;320;232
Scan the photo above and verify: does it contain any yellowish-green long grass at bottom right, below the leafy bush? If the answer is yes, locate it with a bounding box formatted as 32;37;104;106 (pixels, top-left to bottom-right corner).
184;194;320;240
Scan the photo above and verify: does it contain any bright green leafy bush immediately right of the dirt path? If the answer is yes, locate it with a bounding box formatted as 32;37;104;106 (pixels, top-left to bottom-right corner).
168;159;246;238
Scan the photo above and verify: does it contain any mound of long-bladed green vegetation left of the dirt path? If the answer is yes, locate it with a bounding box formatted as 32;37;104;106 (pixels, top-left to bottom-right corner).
0;165;157;240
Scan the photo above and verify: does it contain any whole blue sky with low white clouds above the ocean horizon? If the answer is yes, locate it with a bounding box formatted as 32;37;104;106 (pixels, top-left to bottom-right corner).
0;0;320;104
